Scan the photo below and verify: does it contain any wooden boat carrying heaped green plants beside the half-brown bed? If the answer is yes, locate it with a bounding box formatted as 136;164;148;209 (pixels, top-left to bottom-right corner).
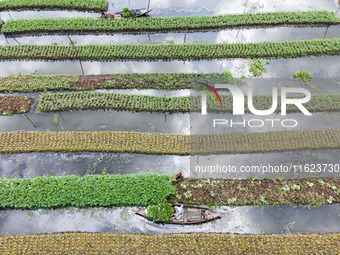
136;205;224;225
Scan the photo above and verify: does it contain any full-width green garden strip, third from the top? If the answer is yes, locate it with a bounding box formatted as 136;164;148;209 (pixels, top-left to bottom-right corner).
0;38;340;61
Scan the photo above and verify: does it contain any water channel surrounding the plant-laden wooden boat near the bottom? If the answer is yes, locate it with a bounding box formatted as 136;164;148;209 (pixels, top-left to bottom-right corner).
0;205;340;235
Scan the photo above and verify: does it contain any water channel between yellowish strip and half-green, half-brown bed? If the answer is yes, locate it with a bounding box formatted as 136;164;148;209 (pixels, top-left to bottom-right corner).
0;149;340;179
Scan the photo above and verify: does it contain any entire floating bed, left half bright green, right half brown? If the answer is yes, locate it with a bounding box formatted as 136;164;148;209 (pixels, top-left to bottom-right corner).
0;175;340;209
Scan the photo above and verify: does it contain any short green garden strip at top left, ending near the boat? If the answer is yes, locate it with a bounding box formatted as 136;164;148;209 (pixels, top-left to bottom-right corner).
0;0;108;11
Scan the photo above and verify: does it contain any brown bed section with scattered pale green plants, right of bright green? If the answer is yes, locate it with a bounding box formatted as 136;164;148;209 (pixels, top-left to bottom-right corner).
175;178;340;206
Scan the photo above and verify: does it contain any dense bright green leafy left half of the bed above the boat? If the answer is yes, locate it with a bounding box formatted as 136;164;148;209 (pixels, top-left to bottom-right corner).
0;174;176;209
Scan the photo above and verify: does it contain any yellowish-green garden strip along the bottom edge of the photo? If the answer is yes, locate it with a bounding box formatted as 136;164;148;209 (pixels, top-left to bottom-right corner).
0;233;340;255
